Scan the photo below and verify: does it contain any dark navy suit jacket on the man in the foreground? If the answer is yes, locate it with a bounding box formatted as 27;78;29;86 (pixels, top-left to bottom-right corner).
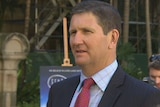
47;66;160;107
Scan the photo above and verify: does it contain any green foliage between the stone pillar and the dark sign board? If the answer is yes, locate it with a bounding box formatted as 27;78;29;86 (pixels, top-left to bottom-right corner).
17;58;40;107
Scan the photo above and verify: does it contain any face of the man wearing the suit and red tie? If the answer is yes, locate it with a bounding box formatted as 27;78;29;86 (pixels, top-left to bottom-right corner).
69;13;115;66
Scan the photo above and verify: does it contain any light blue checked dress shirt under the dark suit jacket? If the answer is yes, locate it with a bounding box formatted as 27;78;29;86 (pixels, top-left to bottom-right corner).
70;60;118;107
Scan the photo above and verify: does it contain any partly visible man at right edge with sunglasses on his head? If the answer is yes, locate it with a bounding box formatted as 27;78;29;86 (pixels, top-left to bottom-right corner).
149;55;160;89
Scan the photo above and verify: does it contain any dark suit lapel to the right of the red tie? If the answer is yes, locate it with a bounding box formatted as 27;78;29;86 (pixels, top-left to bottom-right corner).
98;67;125;107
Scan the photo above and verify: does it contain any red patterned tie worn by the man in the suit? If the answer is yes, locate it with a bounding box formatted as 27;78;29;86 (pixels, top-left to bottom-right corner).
75;78;95;107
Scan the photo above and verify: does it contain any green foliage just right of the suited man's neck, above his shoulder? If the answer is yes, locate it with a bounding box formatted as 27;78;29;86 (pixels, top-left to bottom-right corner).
118;43;145;79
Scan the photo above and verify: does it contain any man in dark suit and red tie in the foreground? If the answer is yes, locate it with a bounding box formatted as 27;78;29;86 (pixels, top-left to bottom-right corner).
47;0;160;107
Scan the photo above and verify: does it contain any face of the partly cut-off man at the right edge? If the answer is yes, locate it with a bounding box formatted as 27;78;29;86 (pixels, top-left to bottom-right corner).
149;68;160;89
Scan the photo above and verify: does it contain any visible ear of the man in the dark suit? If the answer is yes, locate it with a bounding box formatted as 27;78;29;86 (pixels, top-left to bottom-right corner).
109;29;119;48
